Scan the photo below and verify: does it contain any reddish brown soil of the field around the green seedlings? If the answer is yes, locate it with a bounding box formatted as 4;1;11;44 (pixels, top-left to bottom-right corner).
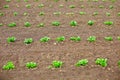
0;0;120;80
